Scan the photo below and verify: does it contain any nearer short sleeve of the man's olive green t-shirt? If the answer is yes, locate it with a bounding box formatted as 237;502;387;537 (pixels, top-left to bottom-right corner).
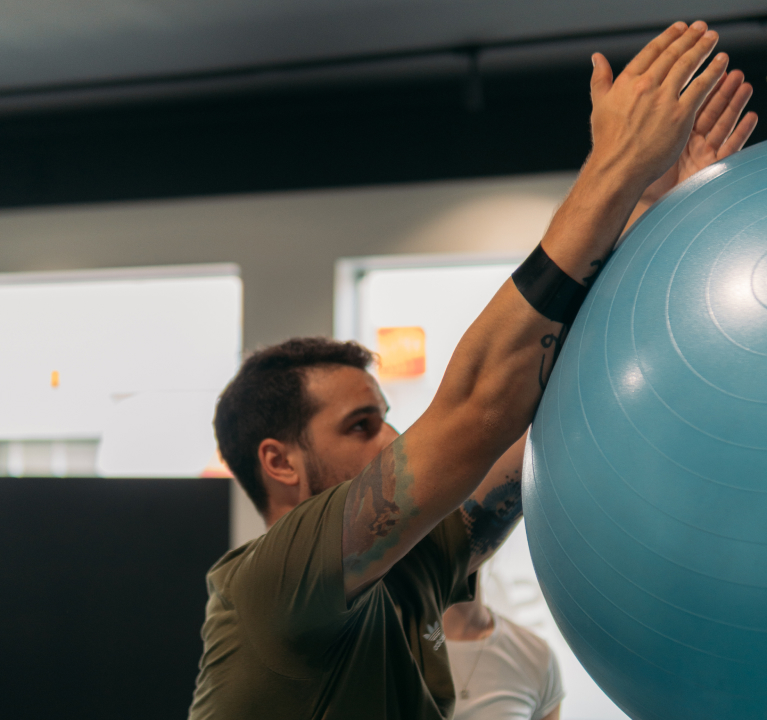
220;482;356;677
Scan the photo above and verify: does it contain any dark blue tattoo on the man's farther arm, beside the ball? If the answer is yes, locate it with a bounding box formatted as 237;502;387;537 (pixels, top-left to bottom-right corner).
461;472;522;555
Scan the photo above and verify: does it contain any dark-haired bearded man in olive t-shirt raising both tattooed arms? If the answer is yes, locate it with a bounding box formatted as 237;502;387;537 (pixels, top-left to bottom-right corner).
190;22;756;720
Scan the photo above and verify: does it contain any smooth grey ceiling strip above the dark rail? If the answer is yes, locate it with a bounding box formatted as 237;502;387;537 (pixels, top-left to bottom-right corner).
0;0;767;102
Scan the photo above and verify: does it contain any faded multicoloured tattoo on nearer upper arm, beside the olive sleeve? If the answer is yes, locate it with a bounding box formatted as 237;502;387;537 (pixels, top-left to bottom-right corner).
343;436;418;574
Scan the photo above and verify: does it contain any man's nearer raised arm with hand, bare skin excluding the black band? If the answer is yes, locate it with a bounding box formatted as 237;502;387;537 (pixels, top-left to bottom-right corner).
343;23;727;598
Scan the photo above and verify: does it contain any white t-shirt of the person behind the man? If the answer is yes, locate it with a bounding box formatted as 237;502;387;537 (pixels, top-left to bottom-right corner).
447;613;565;720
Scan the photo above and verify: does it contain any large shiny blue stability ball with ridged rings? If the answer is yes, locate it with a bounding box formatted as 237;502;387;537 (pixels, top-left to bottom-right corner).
523;143;767;720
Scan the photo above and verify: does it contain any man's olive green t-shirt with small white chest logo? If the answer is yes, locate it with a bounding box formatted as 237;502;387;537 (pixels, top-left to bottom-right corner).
189;482;473;720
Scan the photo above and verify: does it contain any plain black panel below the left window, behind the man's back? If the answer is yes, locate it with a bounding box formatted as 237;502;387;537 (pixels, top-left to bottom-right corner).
0;478;229;720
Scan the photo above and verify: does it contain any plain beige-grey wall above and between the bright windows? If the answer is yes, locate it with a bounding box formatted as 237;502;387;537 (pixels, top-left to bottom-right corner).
0;173;575;544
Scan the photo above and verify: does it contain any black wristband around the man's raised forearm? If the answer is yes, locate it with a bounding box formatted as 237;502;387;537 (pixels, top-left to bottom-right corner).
511;244;589;325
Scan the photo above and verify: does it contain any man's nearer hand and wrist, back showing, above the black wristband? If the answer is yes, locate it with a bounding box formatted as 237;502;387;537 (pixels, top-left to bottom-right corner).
543;21;727;284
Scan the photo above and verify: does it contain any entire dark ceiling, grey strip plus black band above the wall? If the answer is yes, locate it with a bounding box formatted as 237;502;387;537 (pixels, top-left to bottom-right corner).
0;0;767;207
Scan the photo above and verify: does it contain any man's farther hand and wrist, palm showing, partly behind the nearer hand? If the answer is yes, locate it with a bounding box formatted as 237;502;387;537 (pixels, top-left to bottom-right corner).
626;70;758;228
